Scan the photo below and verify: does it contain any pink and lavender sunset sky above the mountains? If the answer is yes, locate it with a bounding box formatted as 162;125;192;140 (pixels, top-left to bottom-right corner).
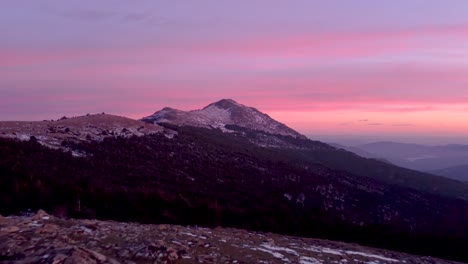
0;0;468;142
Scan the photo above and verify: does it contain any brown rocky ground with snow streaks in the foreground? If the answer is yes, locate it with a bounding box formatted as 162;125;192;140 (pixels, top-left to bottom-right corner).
0;211;462;264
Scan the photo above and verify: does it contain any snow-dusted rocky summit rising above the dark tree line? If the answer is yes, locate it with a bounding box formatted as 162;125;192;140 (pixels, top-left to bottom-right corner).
141;99;305;138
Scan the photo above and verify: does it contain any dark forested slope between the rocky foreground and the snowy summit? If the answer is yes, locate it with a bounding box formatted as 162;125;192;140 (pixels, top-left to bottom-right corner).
0;127;468;259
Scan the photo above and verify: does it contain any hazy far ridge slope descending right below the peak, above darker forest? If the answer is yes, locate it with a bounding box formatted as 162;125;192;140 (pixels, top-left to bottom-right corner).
216;126;468;200
